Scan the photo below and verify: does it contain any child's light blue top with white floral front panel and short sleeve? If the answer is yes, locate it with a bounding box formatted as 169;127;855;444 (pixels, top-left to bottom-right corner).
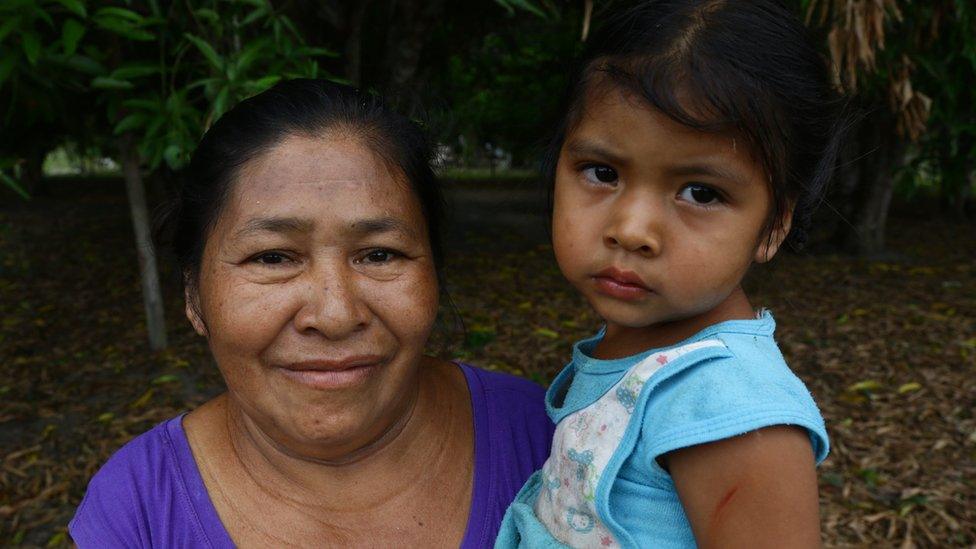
495;311;828;548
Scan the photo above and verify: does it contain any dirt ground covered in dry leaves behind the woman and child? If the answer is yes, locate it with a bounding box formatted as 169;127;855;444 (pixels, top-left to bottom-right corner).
0;181;976;547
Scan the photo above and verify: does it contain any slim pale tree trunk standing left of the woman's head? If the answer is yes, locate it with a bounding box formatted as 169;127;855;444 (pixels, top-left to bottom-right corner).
120;135;166;351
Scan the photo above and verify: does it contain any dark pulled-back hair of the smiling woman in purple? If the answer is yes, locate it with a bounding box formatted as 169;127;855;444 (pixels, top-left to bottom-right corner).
156;79;444;288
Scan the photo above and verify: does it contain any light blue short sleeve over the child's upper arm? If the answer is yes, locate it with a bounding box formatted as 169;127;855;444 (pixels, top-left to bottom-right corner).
640;348;829;464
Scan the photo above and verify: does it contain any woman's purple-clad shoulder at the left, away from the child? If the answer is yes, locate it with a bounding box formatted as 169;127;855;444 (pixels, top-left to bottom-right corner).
68;415;233;548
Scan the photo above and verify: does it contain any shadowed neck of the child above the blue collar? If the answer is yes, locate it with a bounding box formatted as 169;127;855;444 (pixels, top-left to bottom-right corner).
593;286;755;360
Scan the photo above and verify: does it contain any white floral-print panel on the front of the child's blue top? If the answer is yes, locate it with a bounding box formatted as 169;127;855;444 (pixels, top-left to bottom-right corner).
535;339;725;547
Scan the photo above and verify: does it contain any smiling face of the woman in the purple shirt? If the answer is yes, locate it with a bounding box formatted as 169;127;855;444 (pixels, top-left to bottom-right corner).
187;135;438;459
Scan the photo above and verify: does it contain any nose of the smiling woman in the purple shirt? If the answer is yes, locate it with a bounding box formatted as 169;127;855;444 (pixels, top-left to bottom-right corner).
294;262;370;340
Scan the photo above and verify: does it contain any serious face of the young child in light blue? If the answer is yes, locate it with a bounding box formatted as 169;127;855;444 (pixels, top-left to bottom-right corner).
553;91;782;336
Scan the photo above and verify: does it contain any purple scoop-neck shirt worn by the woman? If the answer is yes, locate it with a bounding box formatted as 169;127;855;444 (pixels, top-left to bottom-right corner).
68;364;553;549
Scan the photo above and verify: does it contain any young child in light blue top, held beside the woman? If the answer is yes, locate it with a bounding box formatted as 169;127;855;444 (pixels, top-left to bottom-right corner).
496;0;841;548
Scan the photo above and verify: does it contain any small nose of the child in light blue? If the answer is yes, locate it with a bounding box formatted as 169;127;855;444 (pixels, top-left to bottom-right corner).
603;195;664;257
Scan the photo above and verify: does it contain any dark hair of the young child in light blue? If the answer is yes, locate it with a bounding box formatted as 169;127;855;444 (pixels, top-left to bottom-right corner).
542;0;845;248
